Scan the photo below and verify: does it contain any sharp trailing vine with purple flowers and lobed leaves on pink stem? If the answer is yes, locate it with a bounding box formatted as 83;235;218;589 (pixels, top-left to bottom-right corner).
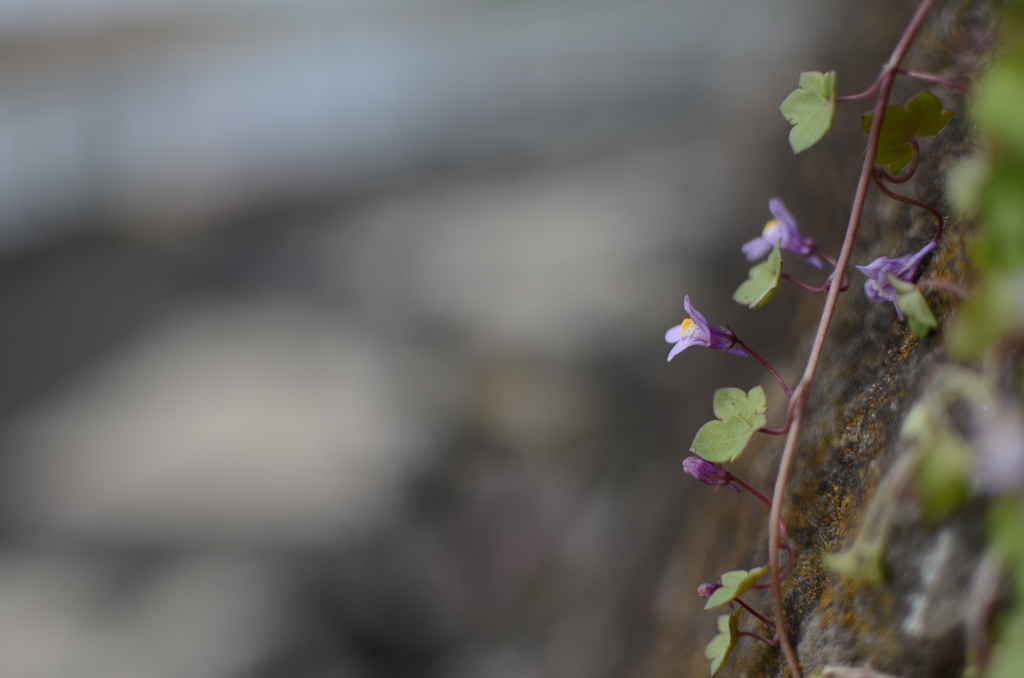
665;0;974;678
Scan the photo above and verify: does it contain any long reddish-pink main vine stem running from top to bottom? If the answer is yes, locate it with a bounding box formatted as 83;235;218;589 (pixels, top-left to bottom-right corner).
768;0;938;678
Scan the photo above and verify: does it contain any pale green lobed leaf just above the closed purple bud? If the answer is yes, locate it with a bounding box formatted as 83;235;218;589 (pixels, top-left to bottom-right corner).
690;386;768;464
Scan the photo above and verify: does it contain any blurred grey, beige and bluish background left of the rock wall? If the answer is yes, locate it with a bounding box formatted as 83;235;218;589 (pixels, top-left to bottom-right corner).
0;0;851;678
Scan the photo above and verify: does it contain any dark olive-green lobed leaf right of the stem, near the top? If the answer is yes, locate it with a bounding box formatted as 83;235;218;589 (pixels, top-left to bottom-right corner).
861;90;953;174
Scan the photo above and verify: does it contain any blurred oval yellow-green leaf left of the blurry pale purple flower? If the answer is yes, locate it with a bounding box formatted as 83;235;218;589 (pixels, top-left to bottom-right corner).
917;428;972;524
